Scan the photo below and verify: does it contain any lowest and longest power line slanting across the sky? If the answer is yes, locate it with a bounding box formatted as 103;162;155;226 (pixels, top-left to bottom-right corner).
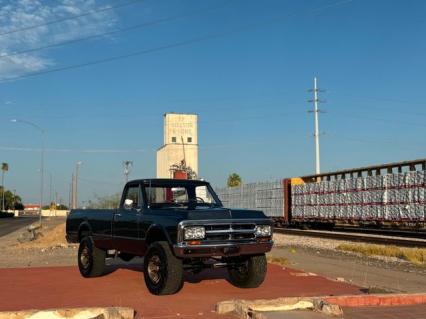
0;0;352;83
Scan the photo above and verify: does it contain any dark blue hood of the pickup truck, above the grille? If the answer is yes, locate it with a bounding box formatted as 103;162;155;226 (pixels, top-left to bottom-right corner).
186;207;266;220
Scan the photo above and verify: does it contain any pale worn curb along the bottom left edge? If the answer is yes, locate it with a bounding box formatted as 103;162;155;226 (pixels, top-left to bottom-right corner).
0;307;135;319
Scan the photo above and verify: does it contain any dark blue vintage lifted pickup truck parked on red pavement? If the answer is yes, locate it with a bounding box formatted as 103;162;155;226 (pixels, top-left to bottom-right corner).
66;179;273;295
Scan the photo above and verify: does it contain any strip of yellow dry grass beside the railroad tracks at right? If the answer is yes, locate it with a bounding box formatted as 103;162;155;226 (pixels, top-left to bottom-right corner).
337;244;426;266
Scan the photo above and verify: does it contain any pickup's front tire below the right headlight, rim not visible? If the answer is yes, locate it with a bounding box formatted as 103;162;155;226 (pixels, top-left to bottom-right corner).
228;254;268;288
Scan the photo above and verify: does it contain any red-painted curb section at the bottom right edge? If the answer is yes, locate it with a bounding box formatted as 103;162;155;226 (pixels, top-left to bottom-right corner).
323;293;426;307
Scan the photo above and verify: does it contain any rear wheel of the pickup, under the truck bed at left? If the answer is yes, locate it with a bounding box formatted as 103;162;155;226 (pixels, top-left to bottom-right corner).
78;236;106;278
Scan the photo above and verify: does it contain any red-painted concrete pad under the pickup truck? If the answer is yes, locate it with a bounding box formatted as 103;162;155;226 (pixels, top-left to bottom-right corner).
0;265;362;318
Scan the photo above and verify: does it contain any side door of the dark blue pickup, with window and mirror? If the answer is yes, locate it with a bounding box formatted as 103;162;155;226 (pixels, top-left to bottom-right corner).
113;184;143;255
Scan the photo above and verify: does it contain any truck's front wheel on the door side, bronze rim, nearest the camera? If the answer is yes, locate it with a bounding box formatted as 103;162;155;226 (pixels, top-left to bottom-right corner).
143;241;183;295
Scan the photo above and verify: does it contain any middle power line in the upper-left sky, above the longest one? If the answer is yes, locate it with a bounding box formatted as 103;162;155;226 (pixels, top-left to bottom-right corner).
0;0;232;59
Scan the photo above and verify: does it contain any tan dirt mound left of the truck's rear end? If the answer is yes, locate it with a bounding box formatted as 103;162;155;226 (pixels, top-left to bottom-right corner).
15;223;68;248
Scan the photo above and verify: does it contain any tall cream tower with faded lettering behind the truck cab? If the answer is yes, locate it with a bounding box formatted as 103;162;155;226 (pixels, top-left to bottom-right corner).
157;113;198;178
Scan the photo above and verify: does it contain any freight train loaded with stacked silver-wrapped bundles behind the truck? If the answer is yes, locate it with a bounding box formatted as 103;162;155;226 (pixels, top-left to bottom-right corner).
216;159;426;228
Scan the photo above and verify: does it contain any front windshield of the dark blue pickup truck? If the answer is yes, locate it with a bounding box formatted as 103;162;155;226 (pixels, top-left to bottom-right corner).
145;185;222;208
